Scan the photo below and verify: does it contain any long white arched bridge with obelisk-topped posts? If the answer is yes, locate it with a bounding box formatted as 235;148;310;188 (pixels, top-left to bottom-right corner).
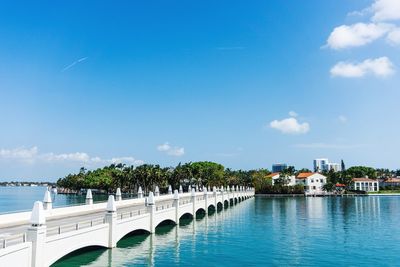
0;187;254;267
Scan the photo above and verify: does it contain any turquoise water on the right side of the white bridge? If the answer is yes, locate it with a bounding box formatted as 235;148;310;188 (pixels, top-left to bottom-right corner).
51;197;400;266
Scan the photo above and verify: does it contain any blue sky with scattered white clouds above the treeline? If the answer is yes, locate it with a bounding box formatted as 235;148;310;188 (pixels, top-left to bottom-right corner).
0;0;400;180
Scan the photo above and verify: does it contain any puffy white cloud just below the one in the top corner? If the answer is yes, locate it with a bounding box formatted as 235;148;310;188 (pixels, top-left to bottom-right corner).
327;23;394;50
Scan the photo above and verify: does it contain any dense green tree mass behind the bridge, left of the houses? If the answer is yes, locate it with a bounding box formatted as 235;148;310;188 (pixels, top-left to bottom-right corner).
57;161;260;193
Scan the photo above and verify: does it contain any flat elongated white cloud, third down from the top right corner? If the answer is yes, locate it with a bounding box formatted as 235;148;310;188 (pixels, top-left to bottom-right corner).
330;57;395;78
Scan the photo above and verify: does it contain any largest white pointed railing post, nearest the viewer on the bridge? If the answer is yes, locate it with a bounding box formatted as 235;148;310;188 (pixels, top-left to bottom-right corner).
27;201;47;267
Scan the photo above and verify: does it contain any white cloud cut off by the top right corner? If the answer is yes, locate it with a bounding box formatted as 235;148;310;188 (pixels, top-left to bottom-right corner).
367;0;400;21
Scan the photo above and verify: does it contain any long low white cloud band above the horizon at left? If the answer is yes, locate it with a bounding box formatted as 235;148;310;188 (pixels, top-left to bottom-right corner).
0;146;143;165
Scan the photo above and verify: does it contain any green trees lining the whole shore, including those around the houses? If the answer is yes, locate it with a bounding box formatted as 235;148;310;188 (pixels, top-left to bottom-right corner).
57;161;400;194
